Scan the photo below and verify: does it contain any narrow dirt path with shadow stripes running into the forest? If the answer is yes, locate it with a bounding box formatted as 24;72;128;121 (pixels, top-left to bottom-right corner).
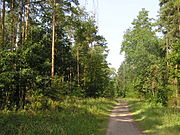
106;100;143;135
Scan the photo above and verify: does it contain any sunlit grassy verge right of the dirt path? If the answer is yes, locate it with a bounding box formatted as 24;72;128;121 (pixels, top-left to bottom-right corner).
127;99;180;135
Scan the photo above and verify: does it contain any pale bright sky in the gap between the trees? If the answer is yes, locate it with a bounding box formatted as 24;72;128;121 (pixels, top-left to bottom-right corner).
79;0;159;70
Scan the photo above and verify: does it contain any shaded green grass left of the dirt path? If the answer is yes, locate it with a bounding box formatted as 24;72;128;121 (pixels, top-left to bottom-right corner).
0;97;115;135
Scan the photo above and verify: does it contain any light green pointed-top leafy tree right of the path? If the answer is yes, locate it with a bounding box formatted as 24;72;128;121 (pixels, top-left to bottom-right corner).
118;9;168;105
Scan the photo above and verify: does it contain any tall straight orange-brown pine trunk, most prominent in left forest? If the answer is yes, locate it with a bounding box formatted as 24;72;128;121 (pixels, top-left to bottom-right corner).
51;0;56;80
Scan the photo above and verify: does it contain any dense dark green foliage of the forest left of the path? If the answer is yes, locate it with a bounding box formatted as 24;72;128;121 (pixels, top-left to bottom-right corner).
0;0;114;110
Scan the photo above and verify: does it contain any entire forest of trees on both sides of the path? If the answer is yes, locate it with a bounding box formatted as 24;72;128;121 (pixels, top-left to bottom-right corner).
0;0;180;110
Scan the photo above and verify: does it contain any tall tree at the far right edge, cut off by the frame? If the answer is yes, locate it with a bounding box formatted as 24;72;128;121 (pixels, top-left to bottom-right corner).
160;0;180;105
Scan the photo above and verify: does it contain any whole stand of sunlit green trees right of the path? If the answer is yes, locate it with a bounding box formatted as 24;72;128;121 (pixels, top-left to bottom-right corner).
116;0;180;106
